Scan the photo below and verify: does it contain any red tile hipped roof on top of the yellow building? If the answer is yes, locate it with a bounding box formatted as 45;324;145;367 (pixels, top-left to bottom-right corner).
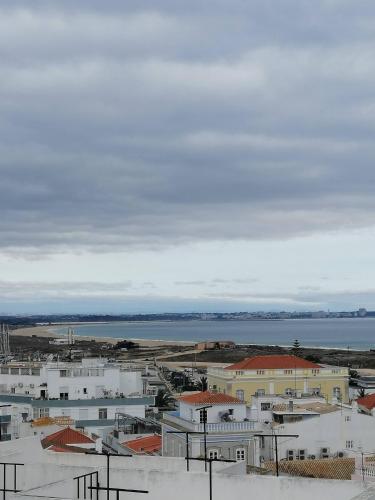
225;354;320;370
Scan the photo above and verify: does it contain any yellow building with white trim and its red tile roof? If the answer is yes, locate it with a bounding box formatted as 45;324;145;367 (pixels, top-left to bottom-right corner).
207;355;349;403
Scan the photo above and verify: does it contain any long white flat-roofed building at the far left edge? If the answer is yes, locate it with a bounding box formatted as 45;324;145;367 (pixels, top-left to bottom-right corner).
0;358;145;399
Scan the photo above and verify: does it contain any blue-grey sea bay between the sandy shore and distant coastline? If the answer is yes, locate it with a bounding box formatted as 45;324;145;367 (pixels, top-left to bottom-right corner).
53;318;375;350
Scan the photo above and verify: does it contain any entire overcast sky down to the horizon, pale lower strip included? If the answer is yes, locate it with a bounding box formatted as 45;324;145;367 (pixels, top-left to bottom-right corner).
0;0;375;313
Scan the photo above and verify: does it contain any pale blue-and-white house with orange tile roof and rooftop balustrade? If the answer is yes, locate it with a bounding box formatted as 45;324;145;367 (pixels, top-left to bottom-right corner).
162;392;255;464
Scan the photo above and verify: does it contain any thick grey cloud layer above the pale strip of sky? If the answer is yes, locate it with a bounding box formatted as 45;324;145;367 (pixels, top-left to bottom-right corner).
0;0;375;256
